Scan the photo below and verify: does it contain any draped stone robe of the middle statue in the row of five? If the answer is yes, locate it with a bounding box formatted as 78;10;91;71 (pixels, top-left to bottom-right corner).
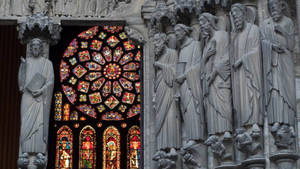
202;31;232;135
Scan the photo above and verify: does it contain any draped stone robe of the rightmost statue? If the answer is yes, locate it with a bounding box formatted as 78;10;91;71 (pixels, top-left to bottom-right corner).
261;16;296;125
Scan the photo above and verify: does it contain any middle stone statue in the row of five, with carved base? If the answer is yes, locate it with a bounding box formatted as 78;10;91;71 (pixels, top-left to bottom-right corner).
199;13;232;162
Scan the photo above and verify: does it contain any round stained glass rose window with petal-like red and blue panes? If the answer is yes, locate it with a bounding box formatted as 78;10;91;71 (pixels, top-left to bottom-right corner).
60;26;142;120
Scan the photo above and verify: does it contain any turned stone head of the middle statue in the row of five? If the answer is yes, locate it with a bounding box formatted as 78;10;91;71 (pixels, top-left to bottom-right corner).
199;12;217;38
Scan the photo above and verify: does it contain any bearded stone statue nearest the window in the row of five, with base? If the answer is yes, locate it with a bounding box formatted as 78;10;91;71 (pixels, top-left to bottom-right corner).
153;33;181;168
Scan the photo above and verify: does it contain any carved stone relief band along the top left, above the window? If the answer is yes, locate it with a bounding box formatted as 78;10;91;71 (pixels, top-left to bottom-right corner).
0;0;131;17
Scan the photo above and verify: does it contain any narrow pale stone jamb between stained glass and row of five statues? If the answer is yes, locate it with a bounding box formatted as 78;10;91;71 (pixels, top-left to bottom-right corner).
142;0;157;169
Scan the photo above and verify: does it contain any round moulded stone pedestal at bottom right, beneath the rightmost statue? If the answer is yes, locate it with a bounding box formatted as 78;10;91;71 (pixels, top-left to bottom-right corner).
270;152;300;169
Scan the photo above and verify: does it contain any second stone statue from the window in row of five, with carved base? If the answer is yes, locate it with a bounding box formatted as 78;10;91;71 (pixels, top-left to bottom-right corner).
175;24;207;169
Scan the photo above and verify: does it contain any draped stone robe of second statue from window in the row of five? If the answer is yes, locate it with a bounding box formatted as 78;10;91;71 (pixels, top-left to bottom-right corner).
179;38;205;140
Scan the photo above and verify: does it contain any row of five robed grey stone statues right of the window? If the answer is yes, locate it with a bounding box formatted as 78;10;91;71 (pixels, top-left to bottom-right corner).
152;0;296;168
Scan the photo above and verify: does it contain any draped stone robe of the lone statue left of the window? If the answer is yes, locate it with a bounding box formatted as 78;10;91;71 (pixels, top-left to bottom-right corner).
19;57;54;153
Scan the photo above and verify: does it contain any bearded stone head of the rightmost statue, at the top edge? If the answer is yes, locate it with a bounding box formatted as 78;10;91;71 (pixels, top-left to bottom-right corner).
268;0;283;22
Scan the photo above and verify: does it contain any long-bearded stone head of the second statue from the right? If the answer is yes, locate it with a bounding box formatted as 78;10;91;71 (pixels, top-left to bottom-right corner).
230;3;246;31
